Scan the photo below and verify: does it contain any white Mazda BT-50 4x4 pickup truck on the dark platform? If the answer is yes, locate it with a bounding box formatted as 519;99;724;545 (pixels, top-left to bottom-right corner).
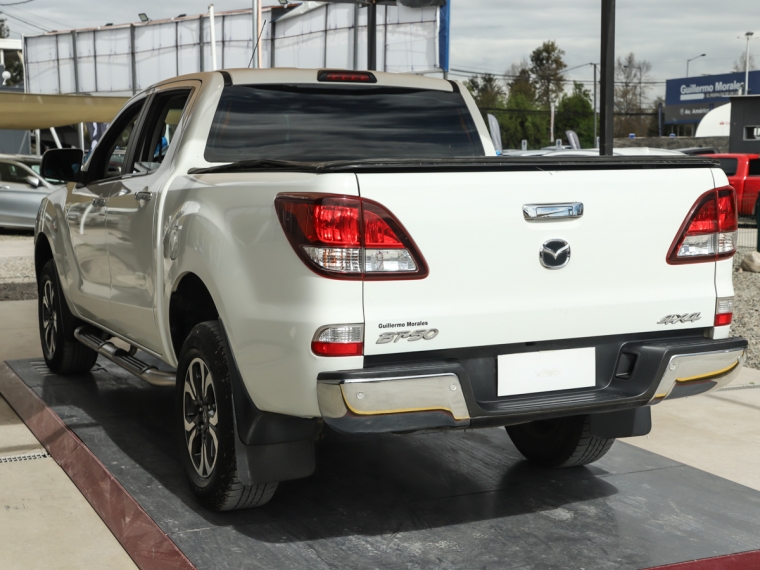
35;69;747;510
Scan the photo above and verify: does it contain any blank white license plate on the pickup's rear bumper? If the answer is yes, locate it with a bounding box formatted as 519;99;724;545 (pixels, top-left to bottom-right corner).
497;347;596;396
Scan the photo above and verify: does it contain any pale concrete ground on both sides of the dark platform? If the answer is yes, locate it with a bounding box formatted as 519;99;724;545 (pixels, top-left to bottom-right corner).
0;296;760;569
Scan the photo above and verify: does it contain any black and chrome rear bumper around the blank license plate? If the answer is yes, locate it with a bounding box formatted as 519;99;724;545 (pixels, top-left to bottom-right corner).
317;330;747;433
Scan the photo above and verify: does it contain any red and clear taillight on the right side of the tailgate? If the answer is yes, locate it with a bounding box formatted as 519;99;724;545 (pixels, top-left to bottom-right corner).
667;186;739;264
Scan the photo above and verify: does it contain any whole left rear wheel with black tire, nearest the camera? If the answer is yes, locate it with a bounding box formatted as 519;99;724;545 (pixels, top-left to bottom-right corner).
176;321;277;511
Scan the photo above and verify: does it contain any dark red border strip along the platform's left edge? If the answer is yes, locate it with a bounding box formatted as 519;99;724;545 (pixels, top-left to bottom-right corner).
0;362;196;570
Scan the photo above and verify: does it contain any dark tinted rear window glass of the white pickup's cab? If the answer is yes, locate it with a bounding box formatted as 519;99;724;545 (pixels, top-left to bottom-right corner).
205;85;485;162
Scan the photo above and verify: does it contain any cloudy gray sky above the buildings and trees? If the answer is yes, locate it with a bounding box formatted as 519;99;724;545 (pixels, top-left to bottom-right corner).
0;0;760;96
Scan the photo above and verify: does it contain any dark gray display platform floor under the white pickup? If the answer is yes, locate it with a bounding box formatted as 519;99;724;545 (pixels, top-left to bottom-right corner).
8;359;760;570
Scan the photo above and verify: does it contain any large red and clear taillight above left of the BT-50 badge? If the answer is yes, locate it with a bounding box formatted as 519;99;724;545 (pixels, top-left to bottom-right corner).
274;193;428;281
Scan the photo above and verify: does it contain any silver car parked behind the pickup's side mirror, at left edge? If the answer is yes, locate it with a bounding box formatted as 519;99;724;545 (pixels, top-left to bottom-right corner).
0;154;62;229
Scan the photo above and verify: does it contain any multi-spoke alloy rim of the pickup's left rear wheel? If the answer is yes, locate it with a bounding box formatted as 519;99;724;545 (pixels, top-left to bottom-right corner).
182;358;219;479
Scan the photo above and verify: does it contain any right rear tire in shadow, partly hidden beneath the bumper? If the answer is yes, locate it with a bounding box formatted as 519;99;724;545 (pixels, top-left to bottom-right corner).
507;415;615;467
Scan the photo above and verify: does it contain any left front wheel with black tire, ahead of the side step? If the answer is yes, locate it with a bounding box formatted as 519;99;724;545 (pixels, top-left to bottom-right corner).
37;259;98;374
